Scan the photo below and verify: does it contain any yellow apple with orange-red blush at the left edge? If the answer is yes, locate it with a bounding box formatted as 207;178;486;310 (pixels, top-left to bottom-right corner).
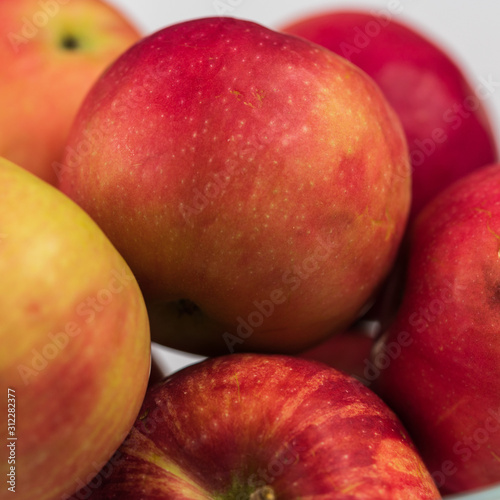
0;159;150;500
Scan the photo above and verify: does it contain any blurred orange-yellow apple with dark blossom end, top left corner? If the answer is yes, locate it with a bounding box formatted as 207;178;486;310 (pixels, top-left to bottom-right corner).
0;0;140;184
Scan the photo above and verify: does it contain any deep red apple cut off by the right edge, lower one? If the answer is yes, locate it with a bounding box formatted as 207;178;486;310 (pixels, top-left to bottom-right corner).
371;164;500;492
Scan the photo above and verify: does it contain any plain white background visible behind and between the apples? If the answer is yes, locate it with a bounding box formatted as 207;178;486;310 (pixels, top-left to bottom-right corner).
100;0;500;373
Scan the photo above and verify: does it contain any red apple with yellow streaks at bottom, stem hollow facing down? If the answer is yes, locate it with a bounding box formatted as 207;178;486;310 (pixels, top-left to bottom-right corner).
67;354;439;500
